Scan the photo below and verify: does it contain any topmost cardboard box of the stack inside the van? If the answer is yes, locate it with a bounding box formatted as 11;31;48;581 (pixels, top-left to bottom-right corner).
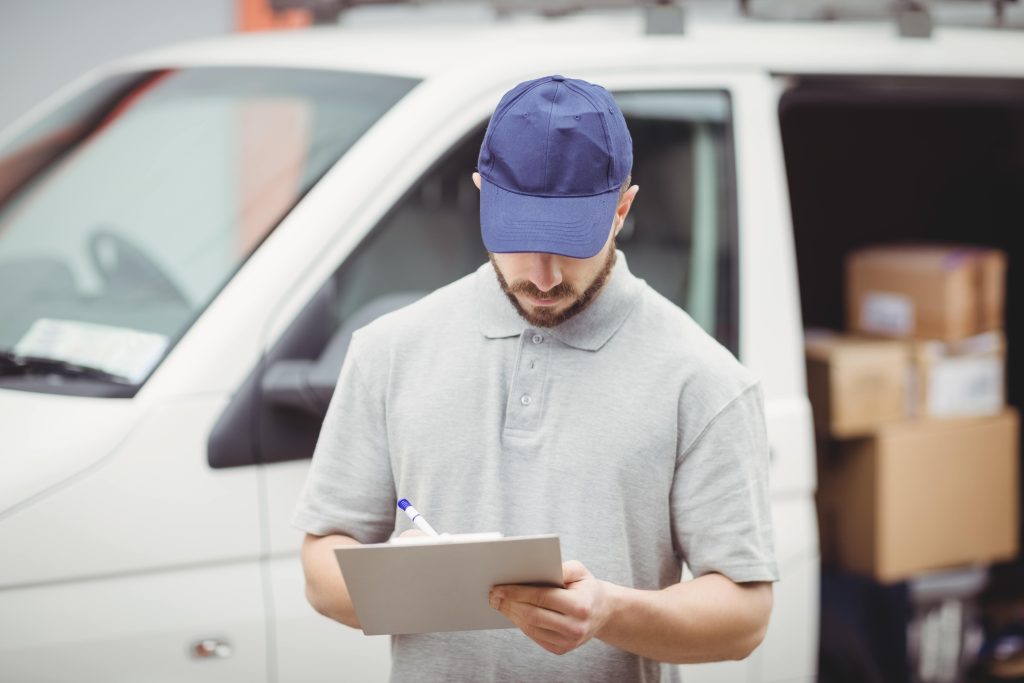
846;246;1007;341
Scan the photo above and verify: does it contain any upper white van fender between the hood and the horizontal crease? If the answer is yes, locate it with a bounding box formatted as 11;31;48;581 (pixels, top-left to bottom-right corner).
0;396;260;589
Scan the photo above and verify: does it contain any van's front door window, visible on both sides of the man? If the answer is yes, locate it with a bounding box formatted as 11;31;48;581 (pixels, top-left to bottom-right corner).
210;91;738;467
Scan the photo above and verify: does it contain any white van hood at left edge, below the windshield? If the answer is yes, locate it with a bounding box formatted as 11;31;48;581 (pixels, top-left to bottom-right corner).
0;389;141;515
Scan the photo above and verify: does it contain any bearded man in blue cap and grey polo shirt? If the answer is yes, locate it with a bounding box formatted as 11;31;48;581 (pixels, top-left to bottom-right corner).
294;76;777;682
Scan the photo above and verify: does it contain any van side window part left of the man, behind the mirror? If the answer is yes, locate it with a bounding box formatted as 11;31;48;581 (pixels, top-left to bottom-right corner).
207;127;487;468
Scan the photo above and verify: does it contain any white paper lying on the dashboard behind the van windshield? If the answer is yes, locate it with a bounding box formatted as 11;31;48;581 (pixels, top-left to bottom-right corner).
13;317;168;384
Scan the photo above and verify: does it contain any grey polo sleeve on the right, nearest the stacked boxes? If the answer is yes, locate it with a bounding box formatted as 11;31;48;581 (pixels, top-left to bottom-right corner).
672;384;778;583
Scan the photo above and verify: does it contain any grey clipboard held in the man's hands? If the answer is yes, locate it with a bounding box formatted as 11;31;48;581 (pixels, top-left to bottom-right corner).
334;533;564;636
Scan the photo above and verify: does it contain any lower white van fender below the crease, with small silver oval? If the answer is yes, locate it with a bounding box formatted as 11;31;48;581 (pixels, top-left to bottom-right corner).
0;561;267;683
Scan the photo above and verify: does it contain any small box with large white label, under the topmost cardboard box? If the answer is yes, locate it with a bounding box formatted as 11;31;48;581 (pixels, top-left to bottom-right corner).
910;331;1007;418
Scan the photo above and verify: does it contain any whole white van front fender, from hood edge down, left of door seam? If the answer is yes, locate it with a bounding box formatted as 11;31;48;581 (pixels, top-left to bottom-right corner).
0;394;268;682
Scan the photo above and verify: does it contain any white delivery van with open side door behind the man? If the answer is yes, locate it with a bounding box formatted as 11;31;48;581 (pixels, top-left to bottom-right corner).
0;6;1024;683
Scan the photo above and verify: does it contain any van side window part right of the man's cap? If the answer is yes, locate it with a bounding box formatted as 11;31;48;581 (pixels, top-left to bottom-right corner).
615;91;738;353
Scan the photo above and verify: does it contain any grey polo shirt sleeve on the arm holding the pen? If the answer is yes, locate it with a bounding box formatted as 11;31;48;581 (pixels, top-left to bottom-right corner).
292;332;395;543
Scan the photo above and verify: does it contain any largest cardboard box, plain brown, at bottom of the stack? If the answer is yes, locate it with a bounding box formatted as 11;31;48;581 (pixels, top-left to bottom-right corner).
818;410;1020;583
